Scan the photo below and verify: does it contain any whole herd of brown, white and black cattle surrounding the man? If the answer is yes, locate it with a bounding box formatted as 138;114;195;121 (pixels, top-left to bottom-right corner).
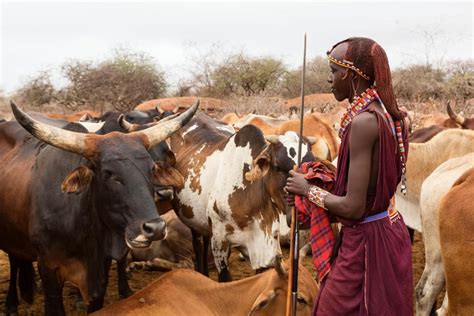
0;98;474;315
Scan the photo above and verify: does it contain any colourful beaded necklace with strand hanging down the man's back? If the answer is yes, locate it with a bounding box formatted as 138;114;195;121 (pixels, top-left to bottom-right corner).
339;87;407;195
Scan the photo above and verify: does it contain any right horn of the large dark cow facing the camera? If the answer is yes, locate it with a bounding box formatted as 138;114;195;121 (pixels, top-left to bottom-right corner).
136;99;200;148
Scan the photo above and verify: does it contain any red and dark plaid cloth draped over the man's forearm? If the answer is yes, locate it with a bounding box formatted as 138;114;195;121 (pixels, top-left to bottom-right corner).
295;162;336;281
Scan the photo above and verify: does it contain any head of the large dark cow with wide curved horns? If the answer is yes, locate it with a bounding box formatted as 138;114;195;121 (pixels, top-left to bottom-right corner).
11;101;199;256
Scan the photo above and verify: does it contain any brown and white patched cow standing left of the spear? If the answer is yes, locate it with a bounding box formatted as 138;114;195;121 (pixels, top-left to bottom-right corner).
170;113;313;281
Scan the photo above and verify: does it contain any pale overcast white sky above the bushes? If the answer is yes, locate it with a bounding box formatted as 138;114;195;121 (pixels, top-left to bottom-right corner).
0;0;474;94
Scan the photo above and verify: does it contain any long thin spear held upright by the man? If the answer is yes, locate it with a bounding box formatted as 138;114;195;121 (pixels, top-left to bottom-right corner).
286;33;306;316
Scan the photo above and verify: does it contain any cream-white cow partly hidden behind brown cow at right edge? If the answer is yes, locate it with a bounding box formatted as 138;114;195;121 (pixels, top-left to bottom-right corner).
415;152;474;315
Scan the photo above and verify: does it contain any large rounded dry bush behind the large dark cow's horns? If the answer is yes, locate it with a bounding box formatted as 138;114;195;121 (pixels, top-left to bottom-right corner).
57;50;167;112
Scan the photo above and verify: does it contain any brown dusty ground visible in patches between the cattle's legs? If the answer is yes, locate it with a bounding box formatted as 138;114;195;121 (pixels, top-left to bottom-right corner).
0;234;442;315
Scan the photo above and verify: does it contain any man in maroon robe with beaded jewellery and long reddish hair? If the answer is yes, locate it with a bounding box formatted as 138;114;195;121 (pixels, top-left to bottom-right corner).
286;37;413;315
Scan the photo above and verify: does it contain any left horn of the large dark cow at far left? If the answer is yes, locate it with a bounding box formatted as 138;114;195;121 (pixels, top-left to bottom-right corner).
10;100;87;155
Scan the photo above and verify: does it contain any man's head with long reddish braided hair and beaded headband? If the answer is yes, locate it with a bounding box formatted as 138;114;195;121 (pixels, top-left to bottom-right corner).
327;37;406;120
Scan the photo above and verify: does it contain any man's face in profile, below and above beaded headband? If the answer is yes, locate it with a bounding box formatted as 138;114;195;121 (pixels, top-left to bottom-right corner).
328;43;351;101
